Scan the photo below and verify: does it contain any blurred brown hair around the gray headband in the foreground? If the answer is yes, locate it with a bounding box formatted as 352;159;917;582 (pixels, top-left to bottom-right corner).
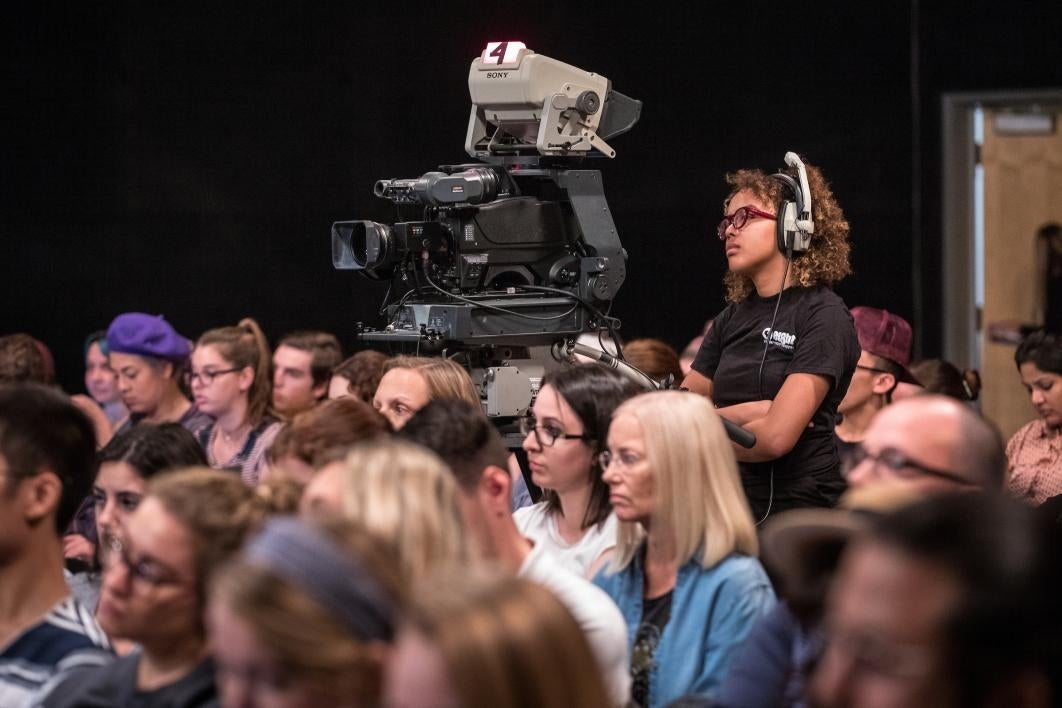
210;519;402;705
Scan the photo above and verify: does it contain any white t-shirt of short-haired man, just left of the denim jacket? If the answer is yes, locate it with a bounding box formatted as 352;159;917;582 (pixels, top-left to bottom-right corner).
516;539;631;706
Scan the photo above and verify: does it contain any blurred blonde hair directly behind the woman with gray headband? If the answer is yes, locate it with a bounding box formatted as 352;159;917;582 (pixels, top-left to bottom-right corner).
329;441;470;582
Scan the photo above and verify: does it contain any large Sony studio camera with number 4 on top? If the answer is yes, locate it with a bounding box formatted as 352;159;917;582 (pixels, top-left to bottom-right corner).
331;42;641;416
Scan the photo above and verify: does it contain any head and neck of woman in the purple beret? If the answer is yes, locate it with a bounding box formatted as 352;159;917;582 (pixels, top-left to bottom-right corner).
107;312;210;434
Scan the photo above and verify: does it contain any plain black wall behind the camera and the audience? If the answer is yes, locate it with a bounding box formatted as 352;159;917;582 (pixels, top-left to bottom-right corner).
0;0;1062;390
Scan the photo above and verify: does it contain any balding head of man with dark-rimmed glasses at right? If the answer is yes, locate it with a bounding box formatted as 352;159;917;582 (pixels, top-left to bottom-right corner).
847;394;1006;491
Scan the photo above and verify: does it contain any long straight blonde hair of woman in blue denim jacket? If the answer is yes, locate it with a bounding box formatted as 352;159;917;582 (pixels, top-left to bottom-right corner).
612;391;757;572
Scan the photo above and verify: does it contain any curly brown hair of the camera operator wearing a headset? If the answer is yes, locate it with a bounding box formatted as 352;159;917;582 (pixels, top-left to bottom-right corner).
723;162;852;303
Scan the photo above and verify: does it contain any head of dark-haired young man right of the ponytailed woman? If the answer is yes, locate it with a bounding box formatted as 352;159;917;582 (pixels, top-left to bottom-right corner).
273;331;343;420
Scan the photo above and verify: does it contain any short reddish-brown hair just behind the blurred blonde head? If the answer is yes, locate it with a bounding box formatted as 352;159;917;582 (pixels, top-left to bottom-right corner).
263;398;391;484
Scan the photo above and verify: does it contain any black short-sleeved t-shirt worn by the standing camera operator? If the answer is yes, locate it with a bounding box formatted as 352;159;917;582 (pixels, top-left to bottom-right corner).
692;287;859;481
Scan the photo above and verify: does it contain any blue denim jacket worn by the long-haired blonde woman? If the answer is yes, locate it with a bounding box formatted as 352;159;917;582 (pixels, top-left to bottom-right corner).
594;552;774;708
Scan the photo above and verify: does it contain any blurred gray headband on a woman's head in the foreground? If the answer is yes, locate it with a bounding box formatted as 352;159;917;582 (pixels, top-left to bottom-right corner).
244;518;394;641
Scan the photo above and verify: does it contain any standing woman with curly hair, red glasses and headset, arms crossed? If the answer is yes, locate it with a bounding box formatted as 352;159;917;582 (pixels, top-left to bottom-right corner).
684;154;859;519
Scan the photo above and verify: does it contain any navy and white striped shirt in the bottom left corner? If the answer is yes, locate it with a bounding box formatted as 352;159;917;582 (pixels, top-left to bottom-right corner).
0;597;115;708
